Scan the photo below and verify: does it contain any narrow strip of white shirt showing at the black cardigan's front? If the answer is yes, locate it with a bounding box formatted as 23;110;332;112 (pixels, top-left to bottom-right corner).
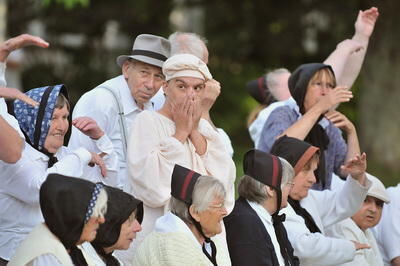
247;200;285;266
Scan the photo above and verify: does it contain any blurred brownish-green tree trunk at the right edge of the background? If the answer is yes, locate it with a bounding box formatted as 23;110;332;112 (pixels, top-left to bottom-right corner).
358;1;400;185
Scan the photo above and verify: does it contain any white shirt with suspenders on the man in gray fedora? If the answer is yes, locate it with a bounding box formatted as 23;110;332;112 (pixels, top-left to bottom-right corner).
68;75;153;193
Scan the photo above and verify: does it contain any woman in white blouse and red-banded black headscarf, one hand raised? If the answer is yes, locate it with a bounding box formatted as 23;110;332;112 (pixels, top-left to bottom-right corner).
271;136;371;265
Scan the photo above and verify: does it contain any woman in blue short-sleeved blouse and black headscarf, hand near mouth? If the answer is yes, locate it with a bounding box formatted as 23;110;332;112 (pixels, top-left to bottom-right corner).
258;63;360;190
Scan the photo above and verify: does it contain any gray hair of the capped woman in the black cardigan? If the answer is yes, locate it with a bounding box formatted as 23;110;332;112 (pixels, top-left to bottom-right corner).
238;157;294;204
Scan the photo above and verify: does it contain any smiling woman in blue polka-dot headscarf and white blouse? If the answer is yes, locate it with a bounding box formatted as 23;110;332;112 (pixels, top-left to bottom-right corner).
0;85;117;261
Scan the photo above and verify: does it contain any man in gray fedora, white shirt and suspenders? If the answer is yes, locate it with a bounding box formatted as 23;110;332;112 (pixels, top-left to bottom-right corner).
69;34;170;193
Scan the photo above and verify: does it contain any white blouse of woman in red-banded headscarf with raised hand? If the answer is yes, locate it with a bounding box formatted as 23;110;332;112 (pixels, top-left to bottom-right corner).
281;176;371;265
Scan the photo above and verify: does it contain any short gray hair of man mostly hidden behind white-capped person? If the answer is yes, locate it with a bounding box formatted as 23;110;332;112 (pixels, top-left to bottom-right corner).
168;32;207;61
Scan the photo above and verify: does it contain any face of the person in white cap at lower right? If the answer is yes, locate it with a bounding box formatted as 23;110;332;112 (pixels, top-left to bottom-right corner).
351;196;383;231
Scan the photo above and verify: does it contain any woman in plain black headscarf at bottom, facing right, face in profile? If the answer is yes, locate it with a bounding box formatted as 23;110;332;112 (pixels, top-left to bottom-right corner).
82;186;143;266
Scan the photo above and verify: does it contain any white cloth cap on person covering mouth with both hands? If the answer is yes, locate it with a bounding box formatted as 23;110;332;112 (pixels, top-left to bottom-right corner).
162;54;212;81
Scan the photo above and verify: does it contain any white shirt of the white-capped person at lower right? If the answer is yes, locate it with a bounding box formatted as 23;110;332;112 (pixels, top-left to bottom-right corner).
326;218;383;266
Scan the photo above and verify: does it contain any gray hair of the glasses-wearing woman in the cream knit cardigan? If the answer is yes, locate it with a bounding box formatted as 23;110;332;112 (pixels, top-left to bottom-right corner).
170;176;226;223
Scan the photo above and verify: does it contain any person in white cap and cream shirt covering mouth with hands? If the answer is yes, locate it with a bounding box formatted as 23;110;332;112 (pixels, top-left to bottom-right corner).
128;54;236;254
